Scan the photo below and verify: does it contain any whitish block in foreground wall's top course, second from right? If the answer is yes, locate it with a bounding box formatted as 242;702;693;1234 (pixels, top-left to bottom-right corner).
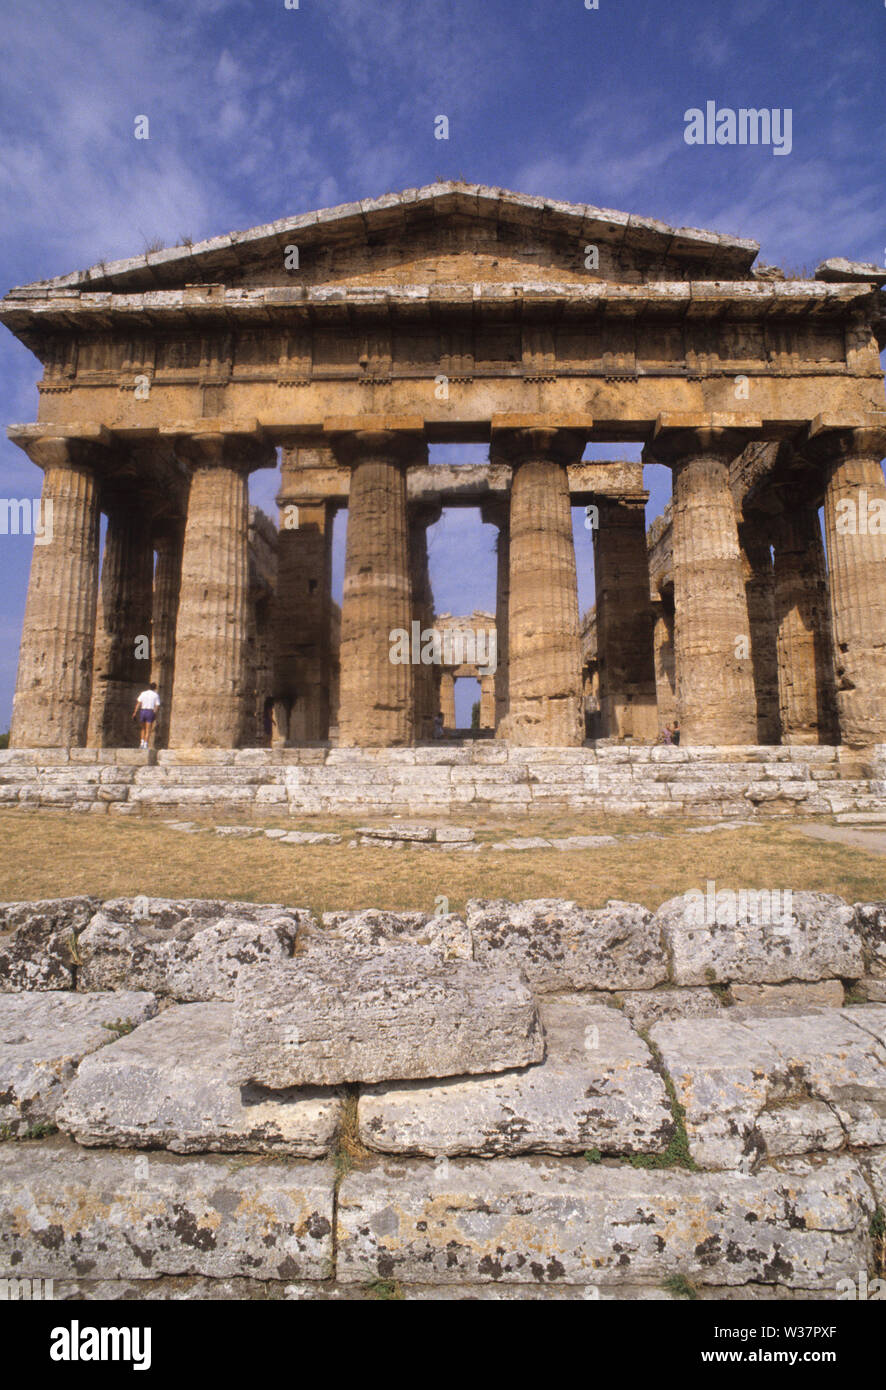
654;890;864;984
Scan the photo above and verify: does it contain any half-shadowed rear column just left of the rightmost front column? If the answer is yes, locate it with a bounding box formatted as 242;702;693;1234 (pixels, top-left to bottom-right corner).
773;505;836;744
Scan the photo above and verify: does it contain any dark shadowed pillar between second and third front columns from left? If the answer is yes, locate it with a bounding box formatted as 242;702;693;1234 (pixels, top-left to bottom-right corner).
273;492;332;745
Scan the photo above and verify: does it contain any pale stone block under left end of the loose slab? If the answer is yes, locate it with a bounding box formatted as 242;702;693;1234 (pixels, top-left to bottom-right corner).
57;1004;341;1158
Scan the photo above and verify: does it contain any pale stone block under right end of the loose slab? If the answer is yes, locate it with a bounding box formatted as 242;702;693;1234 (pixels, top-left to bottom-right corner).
359;995;673;1156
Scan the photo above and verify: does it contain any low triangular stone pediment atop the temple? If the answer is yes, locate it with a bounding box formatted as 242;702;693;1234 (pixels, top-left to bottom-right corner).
8;182;758;296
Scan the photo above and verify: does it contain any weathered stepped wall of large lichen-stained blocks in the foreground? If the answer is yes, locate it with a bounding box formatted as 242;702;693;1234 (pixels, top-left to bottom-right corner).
0;892;886;1300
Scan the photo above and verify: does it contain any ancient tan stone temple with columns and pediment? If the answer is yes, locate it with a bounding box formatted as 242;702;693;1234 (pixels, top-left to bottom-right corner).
0;183;886;748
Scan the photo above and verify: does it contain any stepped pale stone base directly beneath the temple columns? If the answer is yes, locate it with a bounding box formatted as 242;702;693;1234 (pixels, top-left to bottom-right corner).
0;742;886;816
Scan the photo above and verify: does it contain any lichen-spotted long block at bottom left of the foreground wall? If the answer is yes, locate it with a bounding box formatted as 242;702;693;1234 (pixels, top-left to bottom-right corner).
0;1140;334;1282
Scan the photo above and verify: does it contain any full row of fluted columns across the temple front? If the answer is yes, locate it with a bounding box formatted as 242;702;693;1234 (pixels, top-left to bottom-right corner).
11;428;886;748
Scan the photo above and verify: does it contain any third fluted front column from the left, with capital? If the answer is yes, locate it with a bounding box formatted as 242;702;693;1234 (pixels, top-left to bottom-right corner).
330;430;420;748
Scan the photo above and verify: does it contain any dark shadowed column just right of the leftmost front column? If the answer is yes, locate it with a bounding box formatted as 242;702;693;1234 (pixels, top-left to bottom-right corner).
86;488;154;748
